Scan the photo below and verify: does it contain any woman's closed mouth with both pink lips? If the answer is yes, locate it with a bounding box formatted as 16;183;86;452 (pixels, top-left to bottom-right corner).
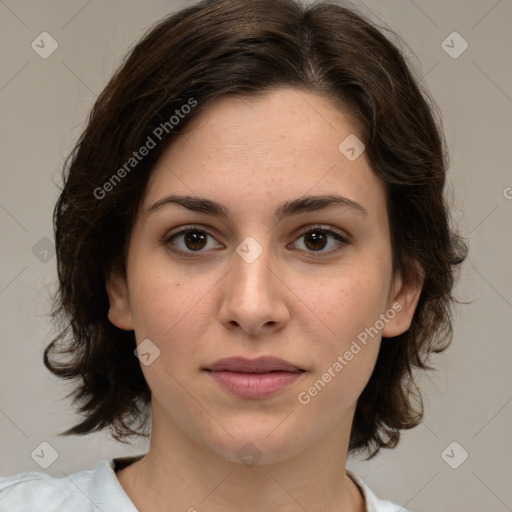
203;357;306;399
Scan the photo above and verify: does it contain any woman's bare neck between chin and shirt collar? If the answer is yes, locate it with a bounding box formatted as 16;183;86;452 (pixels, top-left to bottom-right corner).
117;403;365;512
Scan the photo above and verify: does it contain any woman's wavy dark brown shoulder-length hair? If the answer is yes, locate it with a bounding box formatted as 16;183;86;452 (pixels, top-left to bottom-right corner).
44;0;467;457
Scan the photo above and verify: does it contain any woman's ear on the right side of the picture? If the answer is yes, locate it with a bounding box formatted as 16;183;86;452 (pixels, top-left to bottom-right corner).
382;262;424;338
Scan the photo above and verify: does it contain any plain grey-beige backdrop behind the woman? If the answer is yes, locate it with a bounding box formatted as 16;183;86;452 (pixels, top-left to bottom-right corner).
0;0;512;512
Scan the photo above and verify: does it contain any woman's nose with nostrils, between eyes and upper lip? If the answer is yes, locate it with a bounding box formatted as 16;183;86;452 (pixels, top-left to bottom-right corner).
219;240;292;336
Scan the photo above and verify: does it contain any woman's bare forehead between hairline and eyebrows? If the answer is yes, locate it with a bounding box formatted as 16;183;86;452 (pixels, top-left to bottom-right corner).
144;88;386;224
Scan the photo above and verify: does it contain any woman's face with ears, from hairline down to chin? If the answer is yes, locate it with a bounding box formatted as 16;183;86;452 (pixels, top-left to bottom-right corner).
107;88;419;463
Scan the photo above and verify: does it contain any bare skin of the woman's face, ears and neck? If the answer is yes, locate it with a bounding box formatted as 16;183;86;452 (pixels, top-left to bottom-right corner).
106;88;421;512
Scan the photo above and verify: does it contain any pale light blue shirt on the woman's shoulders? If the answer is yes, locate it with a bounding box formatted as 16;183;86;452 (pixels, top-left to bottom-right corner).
0;455;407;512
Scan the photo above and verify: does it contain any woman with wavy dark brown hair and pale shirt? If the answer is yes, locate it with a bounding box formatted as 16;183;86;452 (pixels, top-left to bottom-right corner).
0;0;466;512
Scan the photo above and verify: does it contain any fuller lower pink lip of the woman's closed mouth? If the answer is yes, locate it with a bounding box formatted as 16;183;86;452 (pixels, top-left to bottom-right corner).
208;370;302;398
